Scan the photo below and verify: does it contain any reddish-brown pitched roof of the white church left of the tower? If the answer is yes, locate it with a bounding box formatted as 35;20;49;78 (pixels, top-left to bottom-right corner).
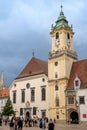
16;57;48;79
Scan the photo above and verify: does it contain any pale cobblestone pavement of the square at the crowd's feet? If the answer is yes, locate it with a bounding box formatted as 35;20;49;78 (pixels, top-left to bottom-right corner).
0;124;87;130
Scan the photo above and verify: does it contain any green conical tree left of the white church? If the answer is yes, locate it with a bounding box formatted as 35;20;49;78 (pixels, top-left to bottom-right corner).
2;98;14;116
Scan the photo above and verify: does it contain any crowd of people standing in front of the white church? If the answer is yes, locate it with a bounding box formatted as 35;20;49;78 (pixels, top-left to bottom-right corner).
0;116;55;130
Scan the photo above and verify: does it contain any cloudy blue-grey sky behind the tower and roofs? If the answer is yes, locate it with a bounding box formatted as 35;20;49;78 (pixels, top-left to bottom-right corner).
0;0;87;86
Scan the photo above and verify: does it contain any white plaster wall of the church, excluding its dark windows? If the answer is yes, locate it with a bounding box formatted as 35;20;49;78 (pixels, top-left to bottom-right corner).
10;74;49;117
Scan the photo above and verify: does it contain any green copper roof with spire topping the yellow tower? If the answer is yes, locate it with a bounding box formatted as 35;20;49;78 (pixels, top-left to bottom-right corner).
53;6;71;30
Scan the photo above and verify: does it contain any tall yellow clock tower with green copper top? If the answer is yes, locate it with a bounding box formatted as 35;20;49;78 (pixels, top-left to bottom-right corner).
48;6;77;122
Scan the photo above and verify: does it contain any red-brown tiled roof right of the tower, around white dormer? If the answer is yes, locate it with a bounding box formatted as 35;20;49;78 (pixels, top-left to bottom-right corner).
67;60;87;90
